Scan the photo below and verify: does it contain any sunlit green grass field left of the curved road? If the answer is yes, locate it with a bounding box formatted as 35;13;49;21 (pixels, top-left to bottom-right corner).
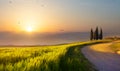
0;41;108;71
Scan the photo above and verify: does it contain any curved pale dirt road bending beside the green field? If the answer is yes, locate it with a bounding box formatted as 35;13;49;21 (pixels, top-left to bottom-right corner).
82;43;120;71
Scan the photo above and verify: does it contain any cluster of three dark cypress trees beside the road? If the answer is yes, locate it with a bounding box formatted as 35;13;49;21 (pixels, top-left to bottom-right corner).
90;27;103;40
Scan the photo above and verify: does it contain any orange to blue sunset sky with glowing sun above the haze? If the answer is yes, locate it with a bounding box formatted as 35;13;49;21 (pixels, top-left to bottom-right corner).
0;0;120;45
